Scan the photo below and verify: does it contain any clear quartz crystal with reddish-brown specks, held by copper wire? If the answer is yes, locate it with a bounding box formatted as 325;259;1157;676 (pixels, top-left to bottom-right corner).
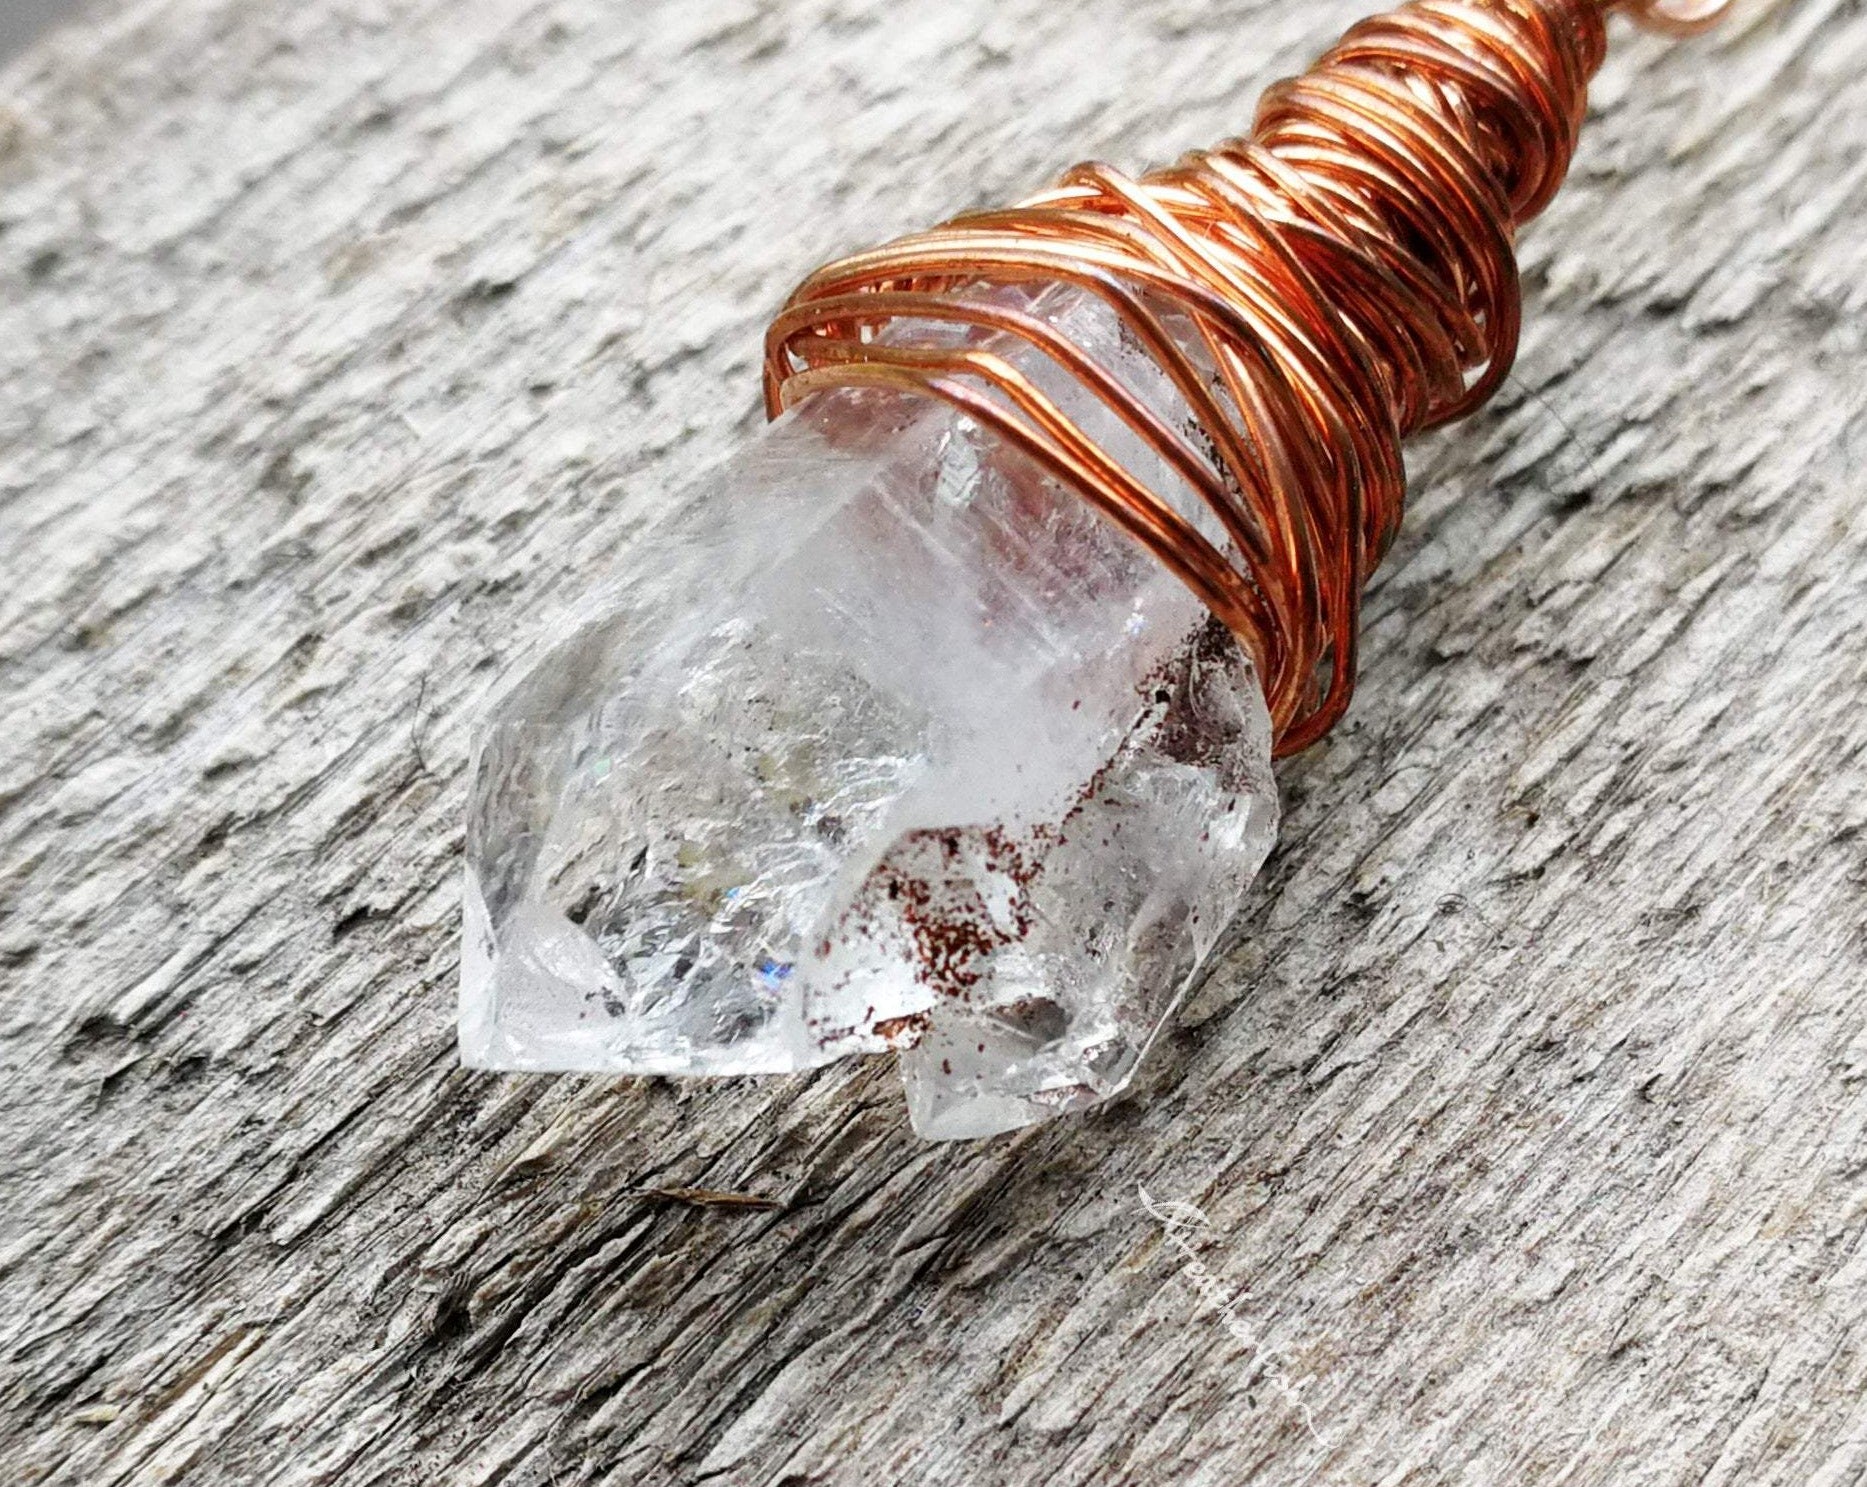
459;288;1277;1138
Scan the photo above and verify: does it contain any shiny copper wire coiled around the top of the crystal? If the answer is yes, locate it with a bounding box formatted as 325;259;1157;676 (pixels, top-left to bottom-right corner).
765;0;1727;755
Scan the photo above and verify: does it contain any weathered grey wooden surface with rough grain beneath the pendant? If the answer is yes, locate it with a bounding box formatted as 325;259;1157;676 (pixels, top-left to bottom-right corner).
0;0;1867;1487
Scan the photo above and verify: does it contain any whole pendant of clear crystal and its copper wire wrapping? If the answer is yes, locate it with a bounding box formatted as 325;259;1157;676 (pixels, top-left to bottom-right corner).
461;0;1723;1136
